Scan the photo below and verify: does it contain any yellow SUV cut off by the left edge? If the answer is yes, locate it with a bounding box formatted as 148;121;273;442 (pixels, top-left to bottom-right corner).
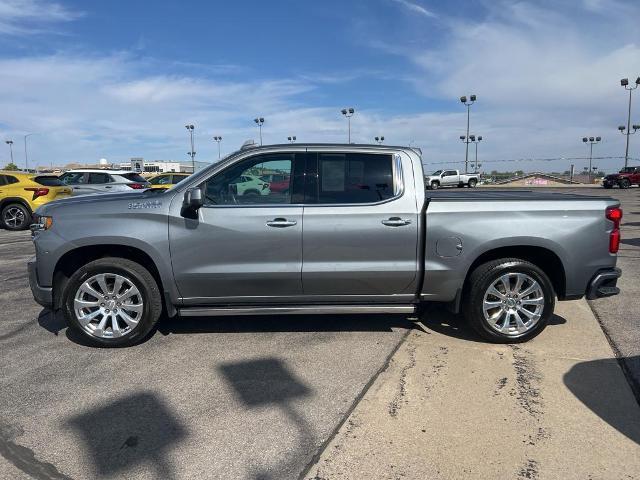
0;170;72;230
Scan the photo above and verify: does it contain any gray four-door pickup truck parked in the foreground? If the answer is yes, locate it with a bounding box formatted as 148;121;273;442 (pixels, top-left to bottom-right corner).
29;144;622;346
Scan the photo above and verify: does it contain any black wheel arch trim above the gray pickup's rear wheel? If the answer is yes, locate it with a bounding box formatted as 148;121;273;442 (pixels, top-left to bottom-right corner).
455;245;567;304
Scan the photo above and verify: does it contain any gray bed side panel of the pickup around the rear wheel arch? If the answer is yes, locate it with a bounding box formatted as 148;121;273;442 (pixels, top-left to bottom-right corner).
422;197;617;301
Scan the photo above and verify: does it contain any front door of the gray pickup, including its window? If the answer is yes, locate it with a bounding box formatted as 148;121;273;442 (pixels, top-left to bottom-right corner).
169;153;304;305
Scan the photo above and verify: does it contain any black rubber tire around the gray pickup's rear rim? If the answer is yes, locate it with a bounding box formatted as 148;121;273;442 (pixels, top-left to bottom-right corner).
463;258;555;343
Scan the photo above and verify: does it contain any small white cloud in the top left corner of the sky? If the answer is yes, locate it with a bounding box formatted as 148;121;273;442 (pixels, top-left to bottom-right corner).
0;0;82;35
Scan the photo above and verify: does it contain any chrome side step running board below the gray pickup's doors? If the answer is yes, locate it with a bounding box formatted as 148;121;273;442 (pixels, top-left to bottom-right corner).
179;305;416;317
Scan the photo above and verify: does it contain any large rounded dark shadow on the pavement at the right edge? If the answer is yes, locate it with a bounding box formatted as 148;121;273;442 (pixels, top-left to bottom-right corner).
563;356;640;444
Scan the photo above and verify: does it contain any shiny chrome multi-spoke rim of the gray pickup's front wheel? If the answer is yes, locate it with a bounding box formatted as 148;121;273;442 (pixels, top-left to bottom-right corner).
73;273;144;338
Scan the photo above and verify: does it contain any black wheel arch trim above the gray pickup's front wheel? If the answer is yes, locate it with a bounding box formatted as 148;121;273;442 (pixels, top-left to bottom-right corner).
52;244;166;314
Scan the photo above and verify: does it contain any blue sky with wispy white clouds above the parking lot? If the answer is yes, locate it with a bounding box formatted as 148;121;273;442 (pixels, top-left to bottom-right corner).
0;0;640;171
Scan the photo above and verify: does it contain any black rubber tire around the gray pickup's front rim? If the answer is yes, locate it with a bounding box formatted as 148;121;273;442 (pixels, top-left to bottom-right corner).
62;257;162;347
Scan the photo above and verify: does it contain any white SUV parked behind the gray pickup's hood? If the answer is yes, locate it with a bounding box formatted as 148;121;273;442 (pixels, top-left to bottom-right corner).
60;169;151;195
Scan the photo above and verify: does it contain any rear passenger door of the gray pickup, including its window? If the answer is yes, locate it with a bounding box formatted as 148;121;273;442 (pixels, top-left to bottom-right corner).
302;151;418;301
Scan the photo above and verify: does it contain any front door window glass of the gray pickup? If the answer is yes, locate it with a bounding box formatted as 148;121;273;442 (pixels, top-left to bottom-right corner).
203;154;294;205
